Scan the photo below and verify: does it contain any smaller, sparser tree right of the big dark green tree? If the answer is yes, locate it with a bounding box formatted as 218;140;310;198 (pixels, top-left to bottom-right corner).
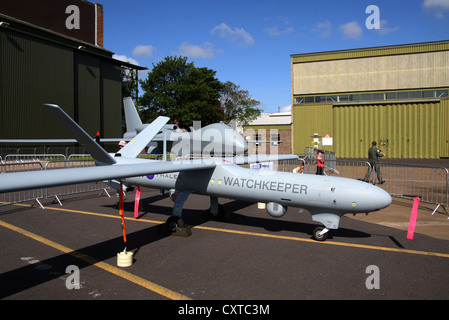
220;81;262;125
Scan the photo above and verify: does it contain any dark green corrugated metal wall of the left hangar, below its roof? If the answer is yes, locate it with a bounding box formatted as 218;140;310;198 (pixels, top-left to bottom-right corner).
0;29;122;139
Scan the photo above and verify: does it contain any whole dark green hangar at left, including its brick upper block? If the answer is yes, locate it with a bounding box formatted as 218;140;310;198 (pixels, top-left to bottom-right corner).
0;0;141;147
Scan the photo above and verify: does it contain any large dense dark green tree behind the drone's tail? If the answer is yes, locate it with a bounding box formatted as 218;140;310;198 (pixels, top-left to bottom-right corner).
140;57;223;127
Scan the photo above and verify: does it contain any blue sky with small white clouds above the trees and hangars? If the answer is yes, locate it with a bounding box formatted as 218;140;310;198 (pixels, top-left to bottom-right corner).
100;0;449;112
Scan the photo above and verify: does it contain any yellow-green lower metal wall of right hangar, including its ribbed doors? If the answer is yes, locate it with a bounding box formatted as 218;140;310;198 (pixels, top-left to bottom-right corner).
293;99;449;158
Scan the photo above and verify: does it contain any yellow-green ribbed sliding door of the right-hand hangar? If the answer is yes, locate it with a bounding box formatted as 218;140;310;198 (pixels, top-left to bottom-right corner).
333;101;440;158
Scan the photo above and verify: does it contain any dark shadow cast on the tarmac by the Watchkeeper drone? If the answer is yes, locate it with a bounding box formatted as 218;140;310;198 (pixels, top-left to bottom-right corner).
0;192;371;299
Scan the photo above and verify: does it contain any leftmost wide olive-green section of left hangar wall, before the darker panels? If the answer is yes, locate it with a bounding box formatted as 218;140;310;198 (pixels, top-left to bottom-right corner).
0;27;73;138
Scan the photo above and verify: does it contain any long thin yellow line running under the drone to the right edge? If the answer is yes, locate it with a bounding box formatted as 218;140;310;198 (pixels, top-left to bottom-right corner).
14;204;449;258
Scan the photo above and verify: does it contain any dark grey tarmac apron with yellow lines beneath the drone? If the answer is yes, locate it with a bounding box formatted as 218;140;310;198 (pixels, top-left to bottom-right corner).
0;184;449;304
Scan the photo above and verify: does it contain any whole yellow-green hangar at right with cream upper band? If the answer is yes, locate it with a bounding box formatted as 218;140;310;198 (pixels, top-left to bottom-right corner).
291;41;449;159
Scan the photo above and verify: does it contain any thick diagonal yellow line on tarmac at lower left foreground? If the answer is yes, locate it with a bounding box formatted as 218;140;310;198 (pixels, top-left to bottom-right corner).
0;220;191;300
